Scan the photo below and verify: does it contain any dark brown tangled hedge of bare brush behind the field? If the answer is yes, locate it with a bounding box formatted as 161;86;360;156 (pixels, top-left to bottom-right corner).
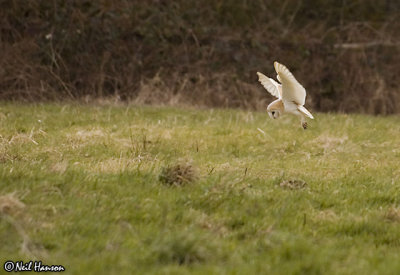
0;0;400;114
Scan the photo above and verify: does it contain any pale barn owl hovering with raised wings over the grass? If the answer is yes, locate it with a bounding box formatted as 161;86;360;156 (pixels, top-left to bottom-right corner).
257;61;314;129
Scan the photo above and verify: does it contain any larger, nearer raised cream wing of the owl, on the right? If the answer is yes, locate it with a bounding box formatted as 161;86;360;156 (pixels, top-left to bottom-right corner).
274;61;306;105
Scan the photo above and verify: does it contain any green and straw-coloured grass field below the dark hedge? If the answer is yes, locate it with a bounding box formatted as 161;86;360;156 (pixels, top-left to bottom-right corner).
0;103;400;274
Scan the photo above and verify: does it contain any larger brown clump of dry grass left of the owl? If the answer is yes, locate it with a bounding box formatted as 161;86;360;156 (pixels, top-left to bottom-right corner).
158;163;196;185
